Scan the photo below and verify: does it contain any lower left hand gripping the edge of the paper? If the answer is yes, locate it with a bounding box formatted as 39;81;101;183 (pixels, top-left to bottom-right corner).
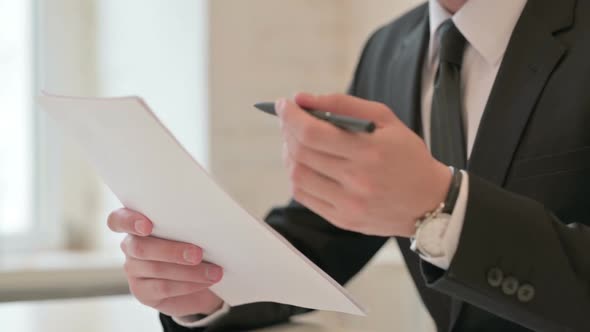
108;209;223;317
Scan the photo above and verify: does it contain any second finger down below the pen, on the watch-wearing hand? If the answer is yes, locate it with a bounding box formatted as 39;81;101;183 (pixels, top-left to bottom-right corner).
284;133;350;182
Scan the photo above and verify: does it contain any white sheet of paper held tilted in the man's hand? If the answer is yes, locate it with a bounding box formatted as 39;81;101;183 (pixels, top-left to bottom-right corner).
38;95;364;315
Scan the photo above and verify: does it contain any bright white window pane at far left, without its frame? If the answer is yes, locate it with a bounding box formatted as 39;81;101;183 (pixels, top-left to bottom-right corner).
0;0;35;237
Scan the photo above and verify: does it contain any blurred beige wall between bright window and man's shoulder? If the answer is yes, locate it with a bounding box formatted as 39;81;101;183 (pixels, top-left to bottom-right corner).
209;0;424;216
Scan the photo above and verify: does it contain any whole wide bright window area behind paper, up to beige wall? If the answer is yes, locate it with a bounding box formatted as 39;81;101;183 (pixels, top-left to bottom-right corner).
0;0;208;255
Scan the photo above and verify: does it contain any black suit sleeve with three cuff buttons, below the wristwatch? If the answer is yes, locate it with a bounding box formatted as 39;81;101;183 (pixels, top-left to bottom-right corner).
422;174;590;331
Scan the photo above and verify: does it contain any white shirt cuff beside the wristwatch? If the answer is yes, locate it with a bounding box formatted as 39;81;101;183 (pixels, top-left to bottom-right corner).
420;171;469;270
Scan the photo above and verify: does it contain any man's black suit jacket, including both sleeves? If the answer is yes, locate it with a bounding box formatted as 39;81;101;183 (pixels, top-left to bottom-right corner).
162;0;590;332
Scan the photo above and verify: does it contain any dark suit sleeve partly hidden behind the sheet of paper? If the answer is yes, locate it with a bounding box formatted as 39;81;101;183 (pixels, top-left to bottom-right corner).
160;201;387;332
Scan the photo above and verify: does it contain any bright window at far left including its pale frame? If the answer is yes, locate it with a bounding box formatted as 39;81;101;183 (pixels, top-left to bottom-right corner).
0;0;63;254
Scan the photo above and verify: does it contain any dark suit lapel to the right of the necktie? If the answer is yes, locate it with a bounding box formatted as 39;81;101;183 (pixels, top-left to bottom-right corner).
468;0;575;185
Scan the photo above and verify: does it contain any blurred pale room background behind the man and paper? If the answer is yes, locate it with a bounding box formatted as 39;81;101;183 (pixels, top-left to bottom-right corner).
0;0;434;332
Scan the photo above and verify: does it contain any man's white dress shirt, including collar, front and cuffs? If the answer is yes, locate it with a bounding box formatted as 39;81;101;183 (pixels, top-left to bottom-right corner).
174;0;527;327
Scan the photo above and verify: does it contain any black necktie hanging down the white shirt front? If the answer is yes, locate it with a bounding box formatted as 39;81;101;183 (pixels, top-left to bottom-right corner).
430;19;467;169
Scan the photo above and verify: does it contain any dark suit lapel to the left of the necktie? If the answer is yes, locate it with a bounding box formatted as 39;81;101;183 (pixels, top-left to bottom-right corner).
385;10;429;135
